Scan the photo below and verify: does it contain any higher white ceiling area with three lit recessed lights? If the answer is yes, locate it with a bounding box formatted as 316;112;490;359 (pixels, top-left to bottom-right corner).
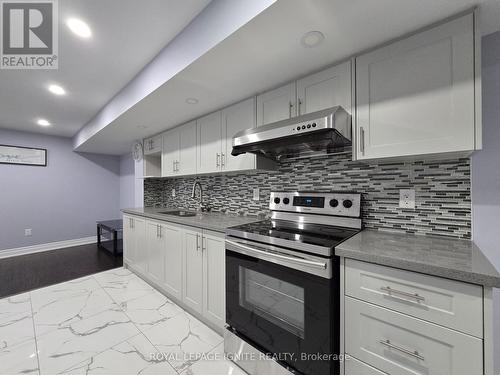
0;0;210;137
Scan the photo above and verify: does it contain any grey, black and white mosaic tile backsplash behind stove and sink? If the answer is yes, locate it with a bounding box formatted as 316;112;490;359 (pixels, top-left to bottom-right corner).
144;155;471;238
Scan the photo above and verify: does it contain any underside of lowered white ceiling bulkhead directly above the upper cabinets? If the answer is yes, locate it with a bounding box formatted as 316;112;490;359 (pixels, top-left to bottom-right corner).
78;0;500;154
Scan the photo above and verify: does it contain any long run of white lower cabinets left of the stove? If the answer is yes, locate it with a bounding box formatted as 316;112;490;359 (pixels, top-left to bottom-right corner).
123;215;226;329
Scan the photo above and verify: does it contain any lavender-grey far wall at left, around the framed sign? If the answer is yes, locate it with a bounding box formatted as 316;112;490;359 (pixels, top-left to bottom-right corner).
0;129;120;250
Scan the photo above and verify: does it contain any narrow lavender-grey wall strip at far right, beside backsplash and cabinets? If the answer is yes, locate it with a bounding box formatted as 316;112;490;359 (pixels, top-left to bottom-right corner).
472;32;500;375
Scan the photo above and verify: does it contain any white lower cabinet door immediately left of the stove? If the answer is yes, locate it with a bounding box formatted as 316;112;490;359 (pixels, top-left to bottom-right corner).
202;232;226;328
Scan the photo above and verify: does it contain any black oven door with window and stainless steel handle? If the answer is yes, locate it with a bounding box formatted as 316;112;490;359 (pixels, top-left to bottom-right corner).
226;237;340;375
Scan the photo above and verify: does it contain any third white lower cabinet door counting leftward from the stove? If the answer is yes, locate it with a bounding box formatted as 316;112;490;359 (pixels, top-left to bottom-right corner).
162;225;183;300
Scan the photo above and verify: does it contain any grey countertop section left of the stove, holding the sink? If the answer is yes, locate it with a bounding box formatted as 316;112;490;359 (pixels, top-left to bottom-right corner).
122;207;261;233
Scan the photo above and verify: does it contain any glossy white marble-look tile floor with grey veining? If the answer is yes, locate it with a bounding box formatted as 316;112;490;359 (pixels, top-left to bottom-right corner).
0;268;245;375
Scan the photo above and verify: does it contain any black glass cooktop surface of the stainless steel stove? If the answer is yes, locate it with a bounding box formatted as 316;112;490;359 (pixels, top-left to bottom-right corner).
227;220;359;255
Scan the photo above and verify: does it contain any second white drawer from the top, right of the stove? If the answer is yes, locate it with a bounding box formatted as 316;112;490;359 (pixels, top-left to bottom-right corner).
345;297;483;375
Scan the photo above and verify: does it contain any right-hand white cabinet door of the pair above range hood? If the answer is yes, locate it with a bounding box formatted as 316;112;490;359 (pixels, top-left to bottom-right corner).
297;61;352;115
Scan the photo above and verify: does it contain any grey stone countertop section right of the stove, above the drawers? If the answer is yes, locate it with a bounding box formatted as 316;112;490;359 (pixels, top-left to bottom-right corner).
335;229;500;288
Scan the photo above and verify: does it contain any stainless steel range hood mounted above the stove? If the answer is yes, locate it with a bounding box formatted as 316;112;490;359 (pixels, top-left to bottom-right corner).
231;106;352;160
